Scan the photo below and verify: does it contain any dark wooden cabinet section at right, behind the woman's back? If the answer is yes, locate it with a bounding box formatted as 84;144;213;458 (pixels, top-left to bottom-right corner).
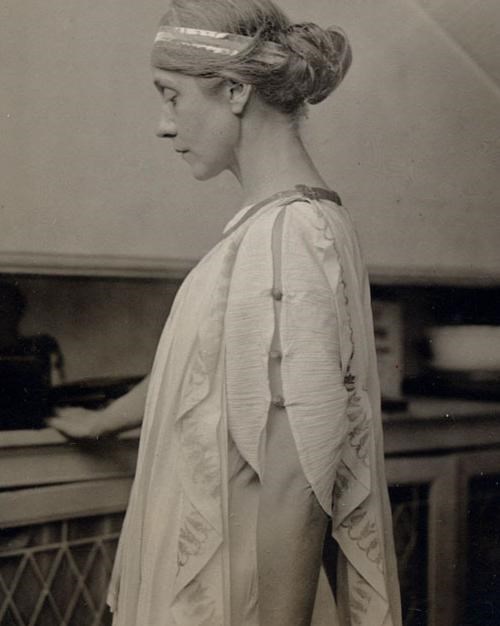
386;417;500;626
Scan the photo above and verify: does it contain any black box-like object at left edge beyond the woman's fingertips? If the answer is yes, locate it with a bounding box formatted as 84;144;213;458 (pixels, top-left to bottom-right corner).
0;356;50;430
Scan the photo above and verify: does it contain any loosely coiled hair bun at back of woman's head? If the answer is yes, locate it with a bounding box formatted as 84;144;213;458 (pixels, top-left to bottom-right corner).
280;22;352;104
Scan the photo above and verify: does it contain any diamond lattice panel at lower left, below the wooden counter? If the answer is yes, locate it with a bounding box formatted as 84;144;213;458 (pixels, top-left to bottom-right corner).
0;515;123;626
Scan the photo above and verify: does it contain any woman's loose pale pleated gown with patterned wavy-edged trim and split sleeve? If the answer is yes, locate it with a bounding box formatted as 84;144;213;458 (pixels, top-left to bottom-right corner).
108;186;401;626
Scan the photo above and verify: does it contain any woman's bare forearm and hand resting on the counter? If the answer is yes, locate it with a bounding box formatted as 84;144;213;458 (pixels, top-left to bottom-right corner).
47;376;149;439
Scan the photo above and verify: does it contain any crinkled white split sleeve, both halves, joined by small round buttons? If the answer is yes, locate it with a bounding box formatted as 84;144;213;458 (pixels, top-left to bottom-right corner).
225;202;347;488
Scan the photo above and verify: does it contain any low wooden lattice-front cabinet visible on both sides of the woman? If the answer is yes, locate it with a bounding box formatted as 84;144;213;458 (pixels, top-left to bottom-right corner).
0;414;500;626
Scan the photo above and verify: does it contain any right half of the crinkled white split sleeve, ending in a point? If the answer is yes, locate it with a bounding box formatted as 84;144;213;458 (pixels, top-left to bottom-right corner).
269;203;349;511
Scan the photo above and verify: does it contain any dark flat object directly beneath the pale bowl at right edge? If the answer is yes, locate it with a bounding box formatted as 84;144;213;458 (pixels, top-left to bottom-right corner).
403;369;500;401
